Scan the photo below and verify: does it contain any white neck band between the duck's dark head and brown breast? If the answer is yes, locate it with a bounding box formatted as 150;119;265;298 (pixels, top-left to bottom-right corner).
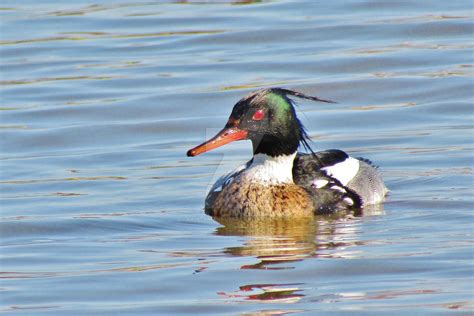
244;151;296;185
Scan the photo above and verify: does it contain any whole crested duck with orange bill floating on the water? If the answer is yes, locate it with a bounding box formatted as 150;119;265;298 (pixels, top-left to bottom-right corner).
187;87;388;219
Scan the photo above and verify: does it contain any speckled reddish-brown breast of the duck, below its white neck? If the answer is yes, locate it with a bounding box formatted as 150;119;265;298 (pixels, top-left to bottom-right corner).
212;180;314;218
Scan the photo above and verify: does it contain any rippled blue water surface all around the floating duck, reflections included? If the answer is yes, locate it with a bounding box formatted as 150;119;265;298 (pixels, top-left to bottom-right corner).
0;0;474;315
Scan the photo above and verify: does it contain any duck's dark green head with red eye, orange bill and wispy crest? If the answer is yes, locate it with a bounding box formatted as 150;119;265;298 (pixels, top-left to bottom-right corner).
187;88;334;157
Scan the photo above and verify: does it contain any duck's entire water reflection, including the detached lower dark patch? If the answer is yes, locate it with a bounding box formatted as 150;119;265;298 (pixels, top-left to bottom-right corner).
215;206;383;303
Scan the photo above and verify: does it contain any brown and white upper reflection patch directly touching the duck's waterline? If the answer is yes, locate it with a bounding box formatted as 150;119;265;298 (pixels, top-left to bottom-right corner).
214;206;383;269
